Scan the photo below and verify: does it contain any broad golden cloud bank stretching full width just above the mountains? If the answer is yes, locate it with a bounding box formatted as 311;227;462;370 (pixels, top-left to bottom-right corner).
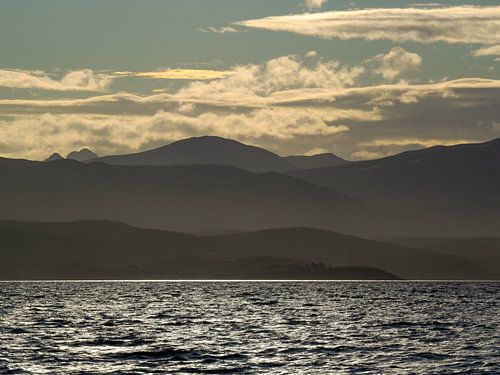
0;53;500;159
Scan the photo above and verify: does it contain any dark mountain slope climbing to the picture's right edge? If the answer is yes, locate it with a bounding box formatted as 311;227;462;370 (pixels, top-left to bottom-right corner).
290;139;500;235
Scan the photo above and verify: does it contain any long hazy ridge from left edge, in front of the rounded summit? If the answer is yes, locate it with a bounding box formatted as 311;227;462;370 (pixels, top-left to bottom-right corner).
0;160;426;235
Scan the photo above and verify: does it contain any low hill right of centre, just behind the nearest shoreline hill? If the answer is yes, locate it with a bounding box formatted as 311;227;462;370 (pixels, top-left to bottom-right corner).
206;228;489;279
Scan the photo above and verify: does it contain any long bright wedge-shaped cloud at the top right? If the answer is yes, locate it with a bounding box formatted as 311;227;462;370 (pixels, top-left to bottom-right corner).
236;5;500;44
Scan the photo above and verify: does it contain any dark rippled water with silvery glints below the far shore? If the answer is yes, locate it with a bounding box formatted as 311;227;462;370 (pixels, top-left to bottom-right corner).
0;282;500;374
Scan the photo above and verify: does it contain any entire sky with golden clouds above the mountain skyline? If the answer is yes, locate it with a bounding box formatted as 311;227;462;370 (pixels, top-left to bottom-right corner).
0;0;500;160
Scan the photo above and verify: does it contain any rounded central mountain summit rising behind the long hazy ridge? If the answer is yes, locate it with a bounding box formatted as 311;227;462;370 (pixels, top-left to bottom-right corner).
98;136;294;172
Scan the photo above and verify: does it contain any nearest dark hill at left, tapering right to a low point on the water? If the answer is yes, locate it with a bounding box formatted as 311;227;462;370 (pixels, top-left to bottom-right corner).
0;221;397;279
